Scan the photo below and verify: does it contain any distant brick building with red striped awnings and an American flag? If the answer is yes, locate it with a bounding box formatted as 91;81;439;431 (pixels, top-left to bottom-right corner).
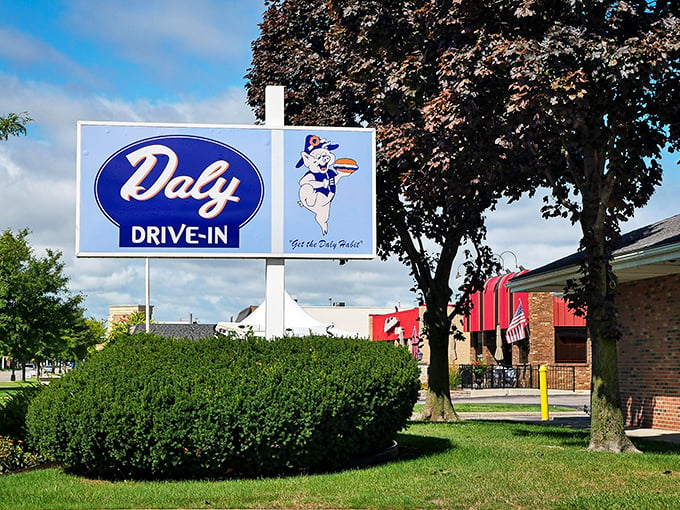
370;284;591;390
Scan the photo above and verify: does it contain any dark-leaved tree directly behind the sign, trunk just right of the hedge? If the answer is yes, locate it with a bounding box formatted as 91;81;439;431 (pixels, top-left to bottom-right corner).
247;0;502;420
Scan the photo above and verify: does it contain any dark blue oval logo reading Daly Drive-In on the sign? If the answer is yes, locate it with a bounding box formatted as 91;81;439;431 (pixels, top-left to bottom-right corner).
94;135;264;248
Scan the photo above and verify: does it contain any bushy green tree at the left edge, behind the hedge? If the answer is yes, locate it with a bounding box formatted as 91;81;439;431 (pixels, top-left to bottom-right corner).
0;230;84;378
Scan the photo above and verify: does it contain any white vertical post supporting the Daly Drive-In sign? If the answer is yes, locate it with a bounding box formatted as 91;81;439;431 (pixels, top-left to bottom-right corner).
264;86;286;340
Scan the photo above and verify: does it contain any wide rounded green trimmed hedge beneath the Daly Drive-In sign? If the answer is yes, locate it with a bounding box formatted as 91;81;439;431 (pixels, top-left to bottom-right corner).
27;334;420;479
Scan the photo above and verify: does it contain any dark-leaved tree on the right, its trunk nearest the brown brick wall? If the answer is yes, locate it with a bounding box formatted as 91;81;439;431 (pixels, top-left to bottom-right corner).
422;0;680;451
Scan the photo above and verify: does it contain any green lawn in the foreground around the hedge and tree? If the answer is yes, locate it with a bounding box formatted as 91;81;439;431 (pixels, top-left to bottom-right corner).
0;420;680;510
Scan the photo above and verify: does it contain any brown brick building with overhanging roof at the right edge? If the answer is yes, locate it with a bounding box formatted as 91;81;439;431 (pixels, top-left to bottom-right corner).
509;215;680;430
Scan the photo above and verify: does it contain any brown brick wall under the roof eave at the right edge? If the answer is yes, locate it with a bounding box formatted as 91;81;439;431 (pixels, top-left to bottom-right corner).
617;275;680;430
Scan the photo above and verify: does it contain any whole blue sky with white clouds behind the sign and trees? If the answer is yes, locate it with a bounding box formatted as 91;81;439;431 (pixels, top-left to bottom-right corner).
0;0;680;322
